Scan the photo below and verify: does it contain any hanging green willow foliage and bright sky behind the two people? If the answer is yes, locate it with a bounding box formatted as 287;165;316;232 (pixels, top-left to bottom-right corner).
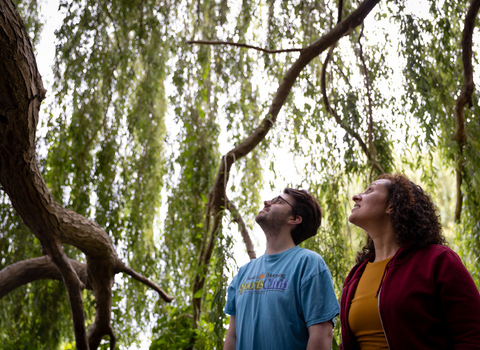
0;0;480;349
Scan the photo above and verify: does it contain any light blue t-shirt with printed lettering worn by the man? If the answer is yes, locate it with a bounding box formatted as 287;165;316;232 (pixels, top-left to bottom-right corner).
224;247;340;350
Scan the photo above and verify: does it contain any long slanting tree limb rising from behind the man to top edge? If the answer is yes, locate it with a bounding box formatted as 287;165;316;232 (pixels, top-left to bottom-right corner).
192;0;380;346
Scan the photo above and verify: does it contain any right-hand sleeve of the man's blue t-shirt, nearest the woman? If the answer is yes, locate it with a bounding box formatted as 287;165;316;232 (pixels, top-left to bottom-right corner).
301;269;340;327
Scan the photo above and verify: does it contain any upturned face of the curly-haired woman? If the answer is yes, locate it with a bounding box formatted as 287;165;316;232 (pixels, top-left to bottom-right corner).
348;179;391;232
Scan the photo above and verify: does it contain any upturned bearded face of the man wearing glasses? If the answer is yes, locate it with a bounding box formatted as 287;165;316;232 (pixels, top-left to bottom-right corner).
255;193;295;231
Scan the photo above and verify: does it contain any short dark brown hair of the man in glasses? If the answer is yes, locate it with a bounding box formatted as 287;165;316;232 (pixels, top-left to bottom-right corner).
283;188;322;245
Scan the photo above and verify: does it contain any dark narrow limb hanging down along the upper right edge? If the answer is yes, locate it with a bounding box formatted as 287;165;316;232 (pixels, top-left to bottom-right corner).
453;0;480;223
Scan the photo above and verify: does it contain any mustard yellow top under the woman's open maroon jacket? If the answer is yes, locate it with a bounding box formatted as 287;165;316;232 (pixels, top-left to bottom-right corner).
348;258;392;350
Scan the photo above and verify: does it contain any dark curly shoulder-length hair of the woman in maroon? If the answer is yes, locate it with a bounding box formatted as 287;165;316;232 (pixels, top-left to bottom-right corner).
356;174;447;263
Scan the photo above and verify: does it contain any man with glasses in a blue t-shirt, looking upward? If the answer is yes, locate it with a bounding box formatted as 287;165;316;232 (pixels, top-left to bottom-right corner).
224;188;339;350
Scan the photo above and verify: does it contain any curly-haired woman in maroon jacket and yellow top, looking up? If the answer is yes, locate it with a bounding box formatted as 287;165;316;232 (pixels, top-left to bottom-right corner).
340;175;480;350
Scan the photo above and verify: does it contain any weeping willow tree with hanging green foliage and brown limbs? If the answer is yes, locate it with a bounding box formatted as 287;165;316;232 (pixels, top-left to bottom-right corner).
0;0;480;349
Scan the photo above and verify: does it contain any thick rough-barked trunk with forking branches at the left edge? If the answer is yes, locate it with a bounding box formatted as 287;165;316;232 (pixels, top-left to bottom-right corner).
0;0;173;349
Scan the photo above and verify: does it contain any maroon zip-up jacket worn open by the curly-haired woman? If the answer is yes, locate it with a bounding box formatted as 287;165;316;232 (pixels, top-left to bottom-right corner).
340;245;480;350
